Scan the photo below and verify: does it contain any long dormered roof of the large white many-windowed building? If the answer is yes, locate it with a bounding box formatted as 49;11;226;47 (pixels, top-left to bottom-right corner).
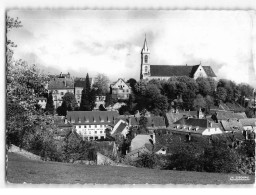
66;111;118;125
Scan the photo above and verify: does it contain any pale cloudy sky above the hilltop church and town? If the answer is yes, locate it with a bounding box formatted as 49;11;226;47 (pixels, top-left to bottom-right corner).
7;10;256;87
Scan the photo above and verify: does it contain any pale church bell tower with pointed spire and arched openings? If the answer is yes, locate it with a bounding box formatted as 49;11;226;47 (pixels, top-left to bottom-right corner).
140;37;150;79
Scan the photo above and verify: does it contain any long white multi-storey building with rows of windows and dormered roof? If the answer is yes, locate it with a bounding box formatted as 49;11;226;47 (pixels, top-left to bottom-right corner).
65;111;118;140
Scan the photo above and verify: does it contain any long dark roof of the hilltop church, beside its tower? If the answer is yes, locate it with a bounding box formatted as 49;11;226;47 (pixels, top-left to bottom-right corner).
150;65;216;77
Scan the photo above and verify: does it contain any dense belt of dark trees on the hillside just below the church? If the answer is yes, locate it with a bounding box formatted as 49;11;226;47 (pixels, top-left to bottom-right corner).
119;76;253;115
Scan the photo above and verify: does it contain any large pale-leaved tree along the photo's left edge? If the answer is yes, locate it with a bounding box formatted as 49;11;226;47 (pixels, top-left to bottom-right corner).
6;16;47;147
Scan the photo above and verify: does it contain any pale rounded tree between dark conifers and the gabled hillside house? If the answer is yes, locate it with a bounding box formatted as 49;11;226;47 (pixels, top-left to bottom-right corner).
93;73;110;95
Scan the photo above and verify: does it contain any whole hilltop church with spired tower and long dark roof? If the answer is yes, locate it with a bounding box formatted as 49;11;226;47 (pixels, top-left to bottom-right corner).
140;38;217;80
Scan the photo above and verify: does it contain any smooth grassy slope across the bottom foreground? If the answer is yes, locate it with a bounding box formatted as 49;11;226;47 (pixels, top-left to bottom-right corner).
7;153;254;184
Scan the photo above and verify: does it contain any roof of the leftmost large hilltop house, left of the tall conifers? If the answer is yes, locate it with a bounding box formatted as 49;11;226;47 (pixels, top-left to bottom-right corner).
48;78;74;90
